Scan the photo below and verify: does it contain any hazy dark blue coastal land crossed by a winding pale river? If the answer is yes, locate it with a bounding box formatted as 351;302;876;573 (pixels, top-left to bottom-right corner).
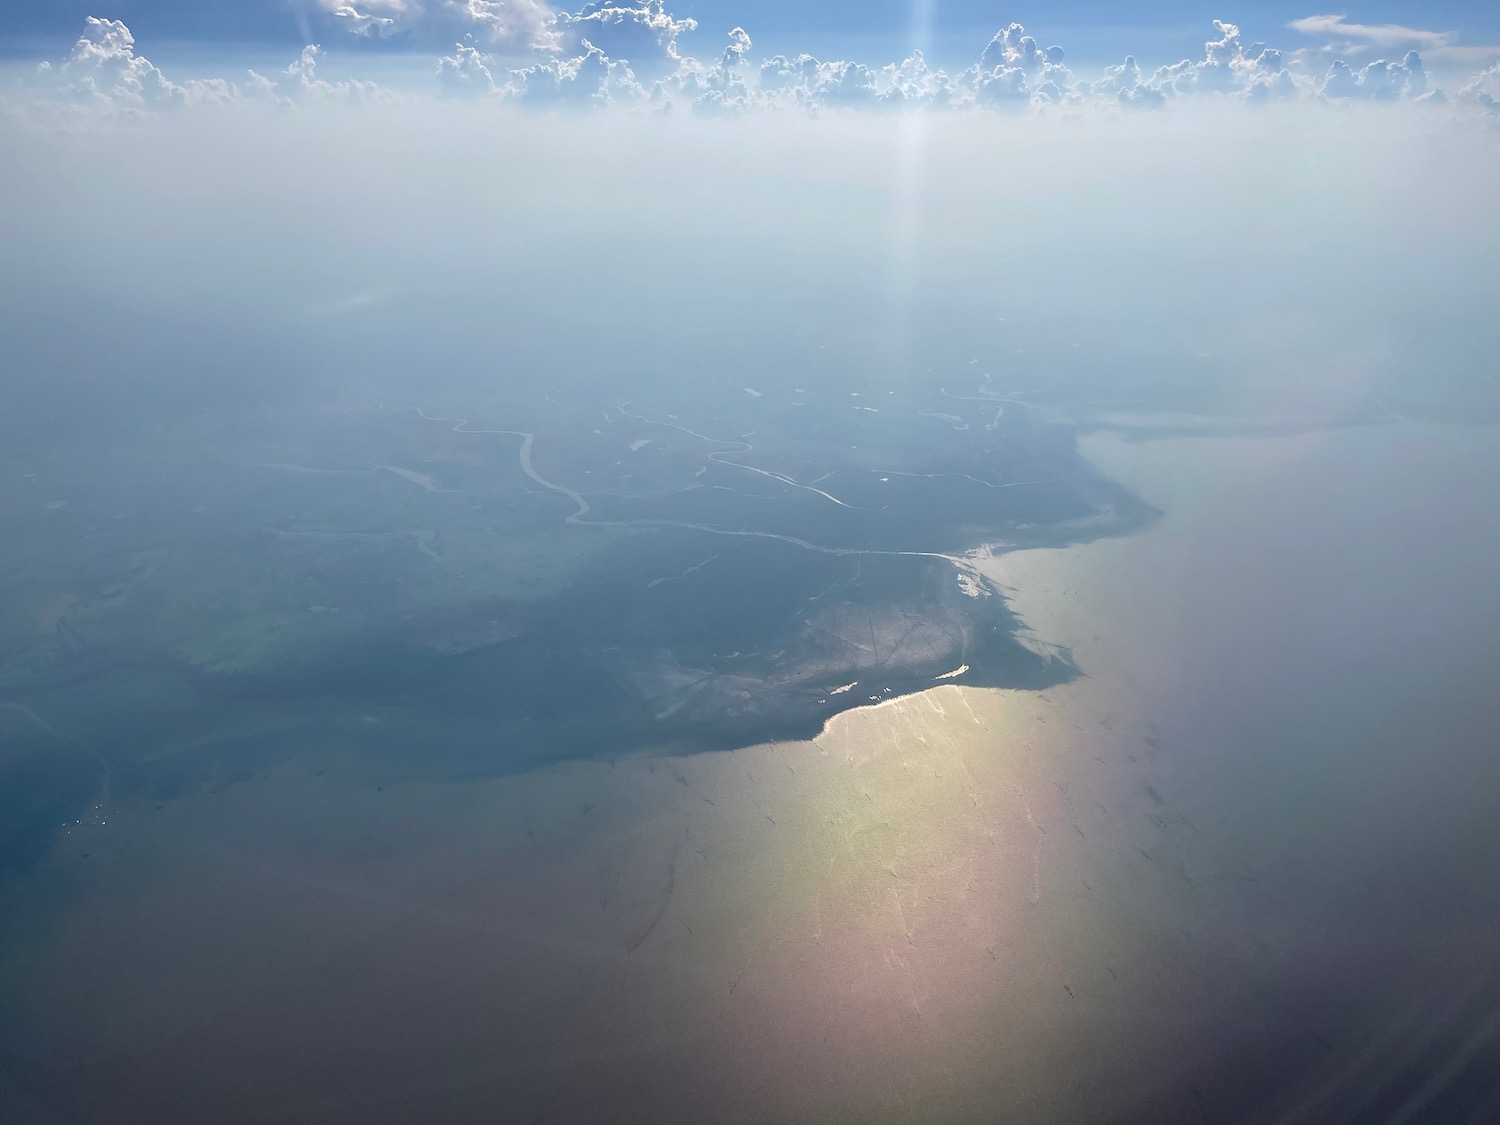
0;367;1155;828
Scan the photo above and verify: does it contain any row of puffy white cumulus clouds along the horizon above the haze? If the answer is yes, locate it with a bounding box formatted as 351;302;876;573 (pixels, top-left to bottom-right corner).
11;0;1494;116
